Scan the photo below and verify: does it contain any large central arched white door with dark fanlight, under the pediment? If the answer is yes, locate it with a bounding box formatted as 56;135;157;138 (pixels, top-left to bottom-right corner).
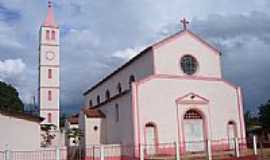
184;110;205;152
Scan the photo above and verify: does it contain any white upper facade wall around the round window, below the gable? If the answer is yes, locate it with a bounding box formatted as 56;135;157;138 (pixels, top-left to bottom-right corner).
154;32;221;78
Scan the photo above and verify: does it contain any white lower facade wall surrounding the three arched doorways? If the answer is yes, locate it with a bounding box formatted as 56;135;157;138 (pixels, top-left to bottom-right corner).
138;78;241;142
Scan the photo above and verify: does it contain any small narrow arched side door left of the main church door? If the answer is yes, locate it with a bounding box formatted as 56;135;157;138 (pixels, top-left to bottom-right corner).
145;123;156;155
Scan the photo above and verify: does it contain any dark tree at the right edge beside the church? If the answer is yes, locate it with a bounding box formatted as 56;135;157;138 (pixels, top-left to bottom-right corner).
259;100;270;130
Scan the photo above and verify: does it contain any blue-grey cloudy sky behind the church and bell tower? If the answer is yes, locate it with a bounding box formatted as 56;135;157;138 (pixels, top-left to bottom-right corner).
0;0;270;112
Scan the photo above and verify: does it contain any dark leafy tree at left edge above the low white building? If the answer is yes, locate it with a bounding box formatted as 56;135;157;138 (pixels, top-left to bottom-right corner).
0;81;24;112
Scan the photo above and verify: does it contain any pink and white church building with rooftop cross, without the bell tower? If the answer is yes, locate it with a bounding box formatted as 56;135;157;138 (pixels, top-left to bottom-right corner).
80;18;245;152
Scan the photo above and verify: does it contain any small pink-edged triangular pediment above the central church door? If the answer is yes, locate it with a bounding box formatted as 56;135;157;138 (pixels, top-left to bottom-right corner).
175;92;209;104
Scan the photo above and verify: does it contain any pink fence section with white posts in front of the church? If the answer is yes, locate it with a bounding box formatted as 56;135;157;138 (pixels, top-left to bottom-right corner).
83;138;266;160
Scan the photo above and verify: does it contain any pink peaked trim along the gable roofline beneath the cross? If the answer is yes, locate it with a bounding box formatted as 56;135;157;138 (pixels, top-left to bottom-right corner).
152;30;220;55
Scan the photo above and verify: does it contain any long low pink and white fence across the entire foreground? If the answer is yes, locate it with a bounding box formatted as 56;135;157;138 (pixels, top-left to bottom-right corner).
0;137;270;160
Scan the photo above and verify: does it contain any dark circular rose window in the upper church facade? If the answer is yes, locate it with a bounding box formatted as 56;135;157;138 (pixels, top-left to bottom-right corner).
181;55;198;75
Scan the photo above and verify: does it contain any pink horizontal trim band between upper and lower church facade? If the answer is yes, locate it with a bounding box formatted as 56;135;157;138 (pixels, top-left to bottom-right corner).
137;74;237;89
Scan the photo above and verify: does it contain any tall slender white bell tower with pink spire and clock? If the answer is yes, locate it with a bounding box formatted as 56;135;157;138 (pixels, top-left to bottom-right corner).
39;1;60;130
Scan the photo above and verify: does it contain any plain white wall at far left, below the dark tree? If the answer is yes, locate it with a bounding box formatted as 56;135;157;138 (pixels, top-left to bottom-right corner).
0;114;40;151
